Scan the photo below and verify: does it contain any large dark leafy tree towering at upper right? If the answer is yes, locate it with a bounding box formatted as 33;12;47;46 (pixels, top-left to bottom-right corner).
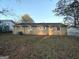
54;0;79;26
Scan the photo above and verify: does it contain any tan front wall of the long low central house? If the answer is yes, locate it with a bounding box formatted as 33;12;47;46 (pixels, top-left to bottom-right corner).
13;26;66;35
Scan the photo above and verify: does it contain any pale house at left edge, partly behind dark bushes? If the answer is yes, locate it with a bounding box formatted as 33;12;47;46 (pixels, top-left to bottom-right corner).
0;20;15;31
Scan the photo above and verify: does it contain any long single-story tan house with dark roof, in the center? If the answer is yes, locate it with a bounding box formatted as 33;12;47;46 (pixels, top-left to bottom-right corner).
13;23;67;35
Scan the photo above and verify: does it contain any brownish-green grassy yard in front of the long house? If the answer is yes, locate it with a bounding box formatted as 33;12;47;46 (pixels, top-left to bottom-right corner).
0;34;79;59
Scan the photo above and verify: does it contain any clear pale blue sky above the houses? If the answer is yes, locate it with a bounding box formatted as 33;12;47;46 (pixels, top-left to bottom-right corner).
0;0;63;23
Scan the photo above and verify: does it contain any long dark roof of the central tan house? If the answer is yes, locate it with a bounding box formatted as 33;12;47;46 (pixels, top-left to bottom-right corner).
15;23;66;27
